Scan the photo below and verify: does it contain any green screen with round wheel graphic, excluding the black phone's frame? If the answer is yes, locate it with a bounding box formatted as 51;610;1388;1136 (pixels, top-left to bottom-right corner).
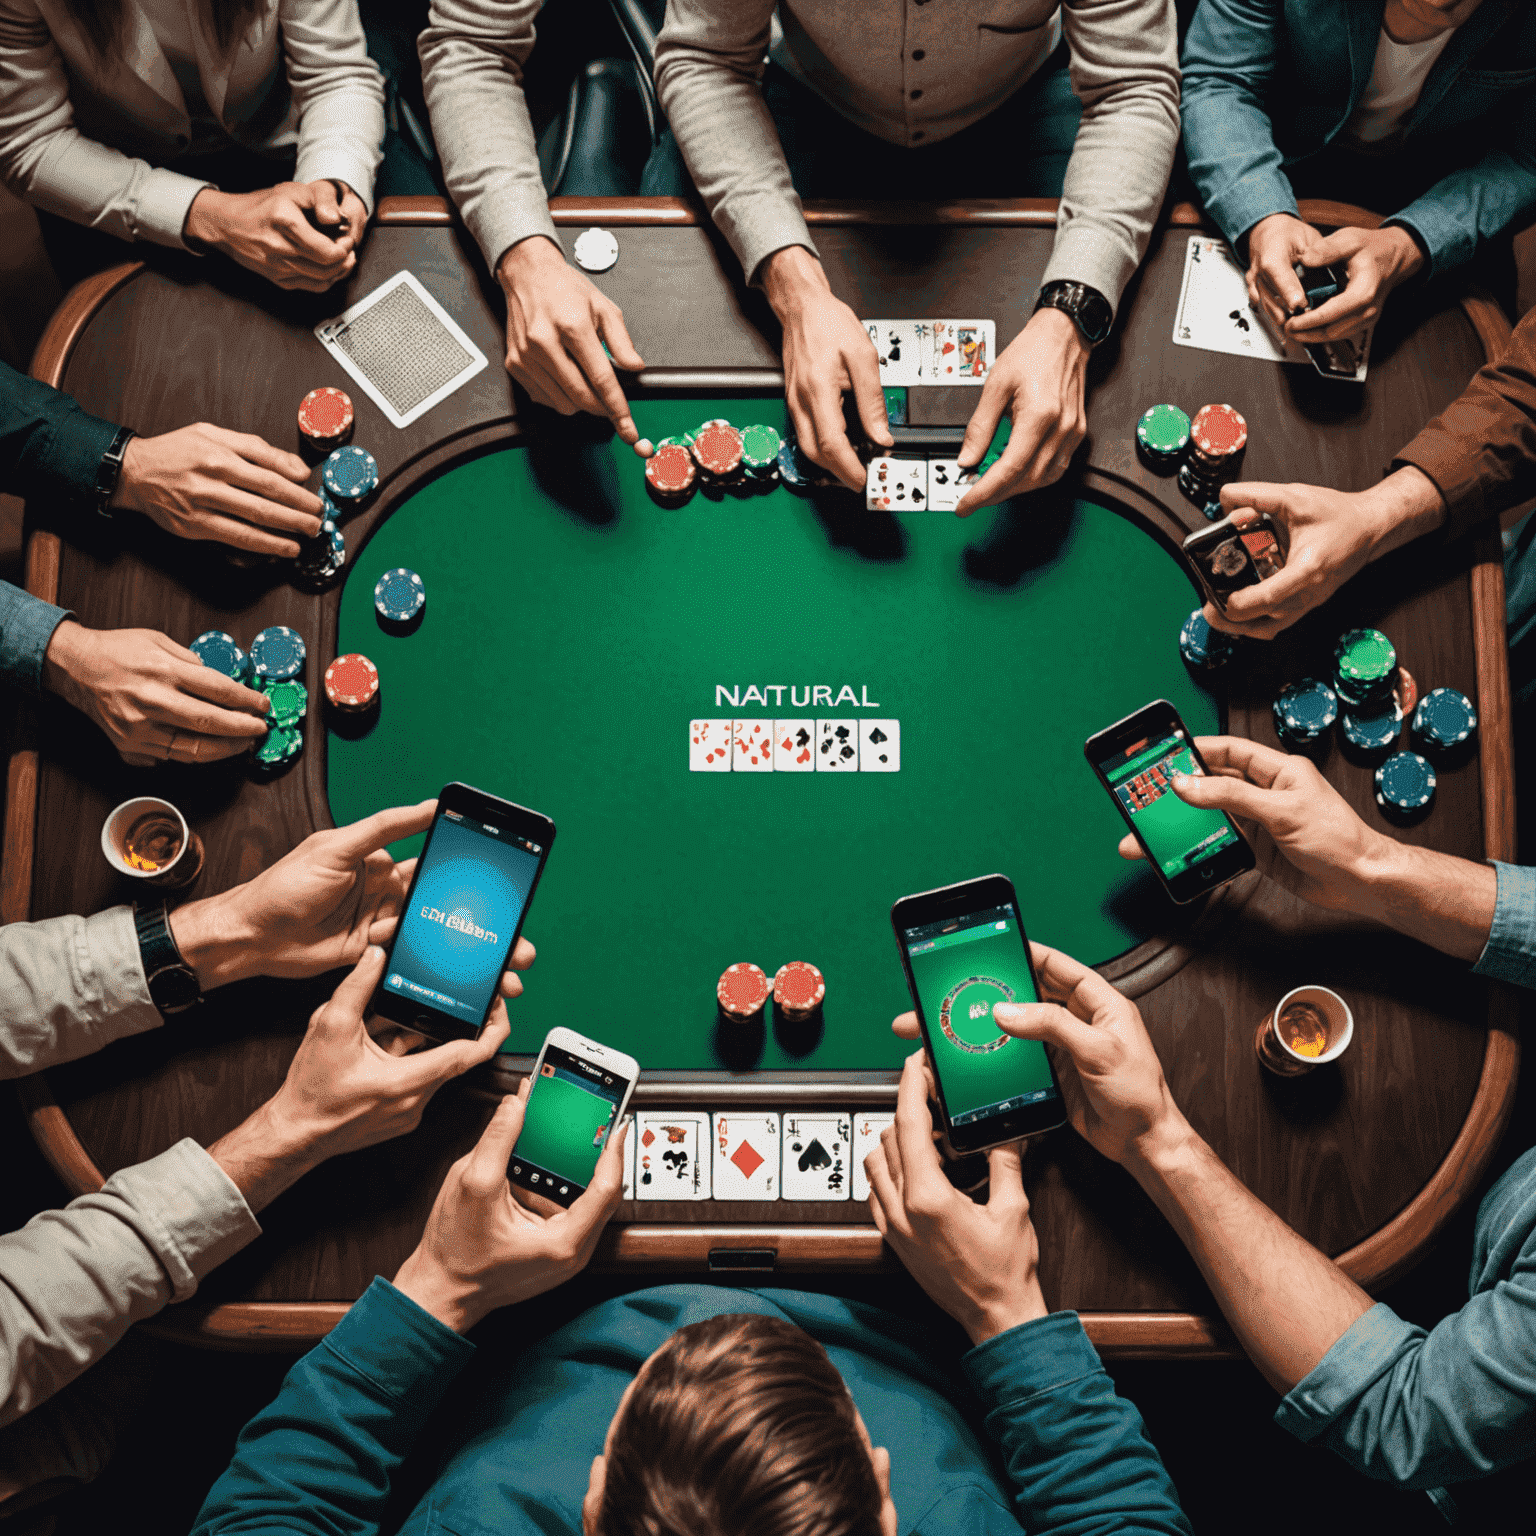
899;902;1061;1141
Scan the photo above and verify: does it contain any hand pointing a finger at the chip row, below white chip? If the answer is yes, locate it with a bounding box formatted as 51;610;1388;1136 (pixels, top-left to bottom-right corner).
496;235;645;447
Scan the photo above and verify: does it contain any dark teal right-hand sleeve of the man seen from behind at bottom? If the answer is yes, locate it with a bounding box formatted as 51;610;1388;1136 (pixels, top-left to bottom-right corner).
963;1312;1190;1536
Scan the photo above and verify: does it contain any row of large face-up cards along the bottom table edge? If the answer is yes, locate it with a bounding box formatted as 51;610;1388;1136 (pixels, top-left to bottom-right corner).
624;1109;895;1201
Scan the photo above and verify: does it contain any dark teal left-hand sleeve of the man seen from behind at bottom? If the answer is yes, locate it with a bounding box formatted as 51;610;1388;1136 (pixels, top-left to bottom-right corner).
192;1279;475;1536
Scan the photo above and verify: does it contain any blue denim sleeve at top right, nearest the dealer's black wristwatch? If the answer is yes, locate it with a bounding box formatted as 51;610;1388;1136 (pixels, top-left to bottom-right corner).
1180;0;1296;246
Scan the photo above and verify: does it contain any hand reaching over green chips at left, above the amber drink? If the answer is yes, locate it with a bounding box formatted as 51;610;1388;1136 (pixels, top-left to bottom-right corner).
43;619;270;768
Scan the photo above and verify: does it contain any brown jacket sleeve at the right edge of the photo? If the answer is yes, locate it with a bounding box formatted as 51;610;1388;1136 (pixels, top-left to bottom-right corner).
1392;310;1536;539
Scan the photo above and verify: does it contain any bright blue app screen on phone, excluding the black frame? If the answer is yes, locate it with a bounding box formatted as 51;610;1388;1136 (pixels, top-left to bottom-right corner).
384;811;544;1025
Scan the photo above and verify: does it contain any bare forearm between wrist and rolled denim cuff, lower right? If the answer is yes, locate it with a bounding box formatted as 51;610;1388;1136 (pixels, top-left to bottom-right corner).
1126;1117;1370;1392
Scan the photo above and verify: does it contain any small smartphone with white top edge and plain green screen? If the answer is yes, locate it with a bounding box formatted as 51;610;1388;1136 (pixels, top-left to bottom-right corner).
507;1025;641;1206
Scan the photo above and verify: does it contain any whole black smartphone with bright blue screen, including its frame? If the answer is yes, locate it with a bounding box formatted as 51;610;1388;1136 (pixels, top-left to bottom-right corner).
370;783;554;1040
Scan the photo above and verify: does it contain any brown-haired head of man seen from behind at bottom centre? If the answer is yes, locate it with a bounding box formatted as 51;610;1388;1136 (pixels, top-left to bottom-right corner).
598;1313;880;1536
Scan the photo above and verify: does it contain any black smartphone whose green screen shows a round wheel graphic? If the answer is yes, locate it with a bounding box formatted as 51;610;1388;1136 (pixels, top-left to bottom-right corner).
891;874;1066;1157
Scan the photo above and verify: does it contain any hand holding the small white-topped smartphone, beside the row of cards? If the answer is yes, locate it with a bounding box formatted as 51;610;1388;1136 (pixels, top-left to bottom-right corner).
395;1077;628;1333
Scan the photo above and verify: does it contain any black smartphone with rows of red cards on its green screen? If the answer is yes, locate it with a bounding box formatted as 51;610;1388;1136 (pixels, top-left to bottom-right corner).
1083;699;1253;902
